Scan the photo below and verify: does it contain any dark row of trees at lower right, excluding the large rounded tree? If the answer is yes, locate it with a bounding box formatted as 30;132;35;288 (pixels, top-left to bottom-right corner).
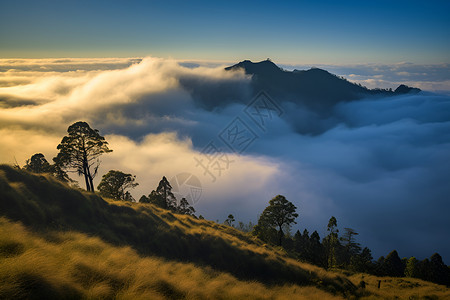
283;221;450;286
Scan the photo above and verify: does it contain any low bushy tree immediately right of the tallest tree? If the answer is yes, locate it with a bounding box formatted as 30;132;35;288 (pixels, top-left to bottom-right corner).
97;170;138;200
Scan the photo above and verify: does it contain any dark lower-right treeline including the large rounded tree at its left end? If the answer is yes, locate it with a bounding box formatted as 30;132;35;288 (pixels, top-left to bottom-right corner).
229;195;450;286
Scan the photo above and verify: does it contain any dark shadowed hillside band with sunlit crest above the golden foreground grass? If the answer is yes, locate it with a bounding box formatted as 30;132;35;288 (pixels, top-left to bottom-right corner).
0;165;356;295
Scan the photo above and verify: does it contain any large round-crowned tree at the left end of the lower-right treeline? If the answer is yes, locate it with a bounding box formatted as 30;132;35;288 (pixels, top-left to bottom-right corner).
258;195;298;246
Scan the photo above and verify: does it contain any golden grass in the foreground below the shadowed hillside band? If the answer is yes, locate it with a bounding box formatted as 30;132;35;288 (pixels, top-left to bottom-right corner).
0;218;343;299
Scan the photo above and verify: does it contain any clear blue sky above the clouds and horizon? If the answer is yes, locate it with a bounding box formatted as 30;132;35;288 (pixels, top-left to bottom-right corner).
0;0;450;64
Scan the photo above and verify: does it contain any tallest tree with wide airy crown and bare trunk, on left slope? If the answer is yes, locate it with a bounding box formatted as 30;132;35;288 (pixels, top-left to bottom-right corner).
53;122;112;191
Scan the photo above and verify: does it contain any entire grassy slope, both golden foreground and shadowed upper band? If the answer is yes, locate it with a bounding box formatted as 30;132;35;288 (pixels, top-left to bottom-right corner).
0;166;448;299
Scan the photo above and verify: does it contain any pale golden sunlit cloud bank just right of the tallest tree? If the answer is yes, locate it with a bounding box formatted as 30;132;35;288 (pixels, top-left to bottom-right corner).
97;133;280;214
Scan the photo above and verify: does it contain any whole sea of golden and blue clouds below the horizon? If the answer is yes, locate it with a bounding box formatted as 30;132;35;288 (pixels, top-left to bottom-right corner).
0;58;450;259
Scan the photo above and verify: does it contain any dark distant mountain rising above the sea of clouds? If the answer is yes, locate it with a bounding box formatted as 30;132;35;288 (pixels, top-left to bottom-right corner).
225;60;420;112
